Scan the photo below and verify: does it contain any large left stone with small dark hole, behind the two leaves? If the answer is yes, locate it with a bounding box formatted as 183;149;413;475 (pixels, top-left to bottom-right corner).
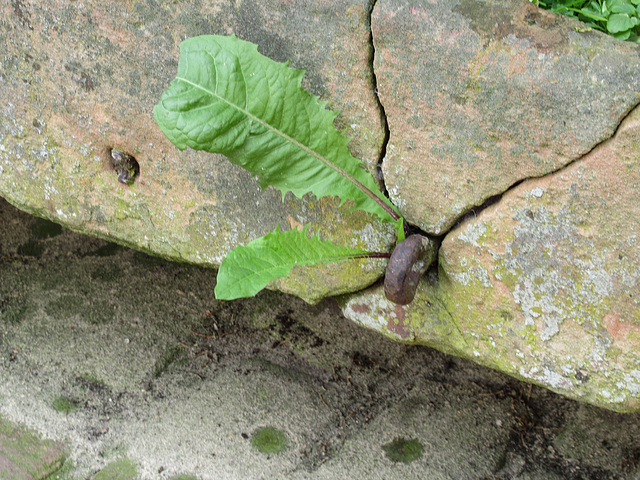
0;0;393;301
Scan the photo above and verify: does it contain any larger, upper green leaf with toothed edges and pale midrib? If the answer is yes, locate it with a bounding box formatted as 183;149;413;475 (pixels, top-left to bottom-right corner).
153;35;399;223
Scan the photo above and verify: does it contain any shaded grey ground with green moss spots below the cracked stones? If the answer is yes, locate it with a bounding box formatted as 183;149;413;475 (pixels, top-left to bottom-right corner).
0;199;640;480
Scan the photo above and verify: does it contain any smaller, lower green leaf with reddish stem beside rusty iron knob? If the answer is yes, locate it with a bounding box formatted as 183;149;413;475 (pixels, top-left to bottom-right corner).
215;228;369;300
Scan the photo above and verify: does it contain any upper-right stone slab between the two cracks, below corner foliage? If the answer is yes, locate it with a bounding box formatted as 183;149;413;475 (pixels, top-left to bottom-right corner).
372;0;640;234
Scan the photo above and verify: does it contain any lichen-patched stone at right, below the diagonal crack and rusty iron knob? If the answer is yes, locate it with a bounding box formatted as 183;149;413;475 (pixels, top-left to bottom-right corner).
344;104;640;411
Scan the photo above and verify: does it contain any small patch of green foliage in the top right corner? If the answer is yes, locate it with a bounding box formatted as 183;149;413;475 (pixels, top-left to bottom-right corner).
531;0;640;43
